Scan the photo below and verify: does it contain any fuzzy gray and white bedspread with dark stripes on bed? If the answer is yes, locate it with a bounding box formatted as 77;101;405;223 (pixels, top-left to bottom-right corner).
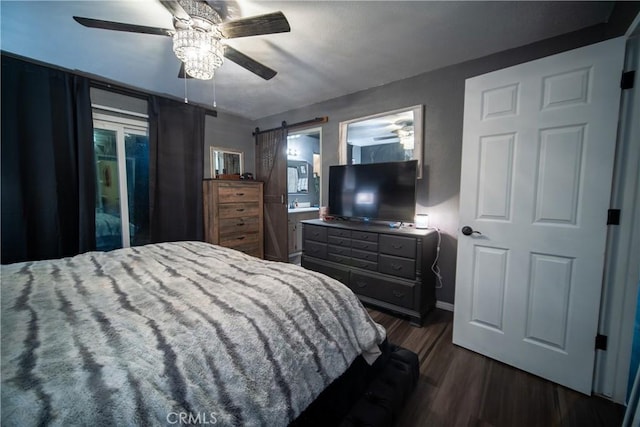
1;242;385;426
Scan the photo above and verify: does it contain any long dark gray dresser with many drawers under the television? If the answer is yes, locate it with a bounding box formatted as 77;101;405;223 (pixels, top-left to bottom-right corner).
302;219;437;326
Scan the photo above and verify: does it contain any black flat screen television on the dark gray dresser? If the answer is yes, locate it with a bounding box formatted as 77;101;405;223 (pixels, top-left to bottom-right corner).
328;160;418;222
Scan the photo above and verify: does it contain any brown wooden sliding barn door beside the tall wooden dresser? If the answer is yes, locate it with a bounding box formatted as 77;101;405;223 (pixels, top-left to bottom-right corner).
256;129;289;262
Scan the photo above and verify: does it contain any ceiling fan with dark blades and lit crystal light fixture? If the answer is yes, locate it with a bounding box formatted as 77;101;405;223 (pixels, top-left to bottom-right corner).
73;0;291;80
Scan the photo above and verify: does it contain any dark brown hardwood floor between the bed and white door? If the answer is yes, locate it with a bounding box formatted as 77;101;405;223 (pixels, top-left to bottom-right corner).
369;309;624;427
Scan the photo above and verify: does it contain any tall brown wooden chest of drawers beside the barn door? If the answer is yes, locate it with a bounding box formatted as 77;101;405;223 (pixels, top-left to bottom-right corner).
203;179;264;258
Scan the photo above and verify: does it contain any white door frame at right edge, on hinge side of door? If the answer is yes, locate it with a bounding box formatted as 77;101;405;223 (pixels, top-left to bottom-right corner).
594;28;640;404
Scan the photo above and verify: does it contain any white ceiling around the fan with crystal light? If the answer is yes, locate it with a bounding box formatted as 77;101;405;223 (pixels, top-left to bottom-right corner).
0;0;613;119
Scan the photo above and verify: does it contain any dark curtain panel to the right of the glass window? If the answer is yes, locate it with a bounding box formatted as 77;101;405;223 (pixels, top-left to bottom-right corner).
149;97;205;243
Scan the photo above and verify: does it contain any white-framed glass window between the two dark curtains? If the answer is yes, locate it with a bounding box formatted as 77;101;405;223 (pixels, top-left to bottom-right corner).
93;112;149;251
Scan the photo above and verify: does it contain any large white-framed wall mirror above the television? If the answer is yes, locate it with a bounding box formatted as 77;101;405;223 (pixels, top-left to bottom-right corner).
339;105;424;178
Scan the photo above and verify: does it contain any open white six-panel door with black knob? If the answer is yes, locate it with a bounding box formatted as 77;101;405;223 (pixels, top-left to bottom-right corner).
453;38;624;394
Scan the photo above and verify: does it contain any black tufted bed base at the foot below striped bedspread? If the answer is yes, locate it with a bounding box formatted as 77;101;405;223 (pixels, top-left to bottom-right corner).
289;340;420;427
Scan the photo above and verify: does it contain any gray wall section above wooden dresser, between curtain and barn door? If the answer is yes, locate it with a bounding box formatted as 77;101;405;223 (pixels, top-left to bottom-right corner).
204;111;255;178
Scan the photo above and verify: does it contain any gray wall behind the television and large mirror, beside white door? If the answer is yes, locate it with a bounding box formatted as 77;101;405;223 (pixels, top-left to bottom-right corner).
254;17;637;303
